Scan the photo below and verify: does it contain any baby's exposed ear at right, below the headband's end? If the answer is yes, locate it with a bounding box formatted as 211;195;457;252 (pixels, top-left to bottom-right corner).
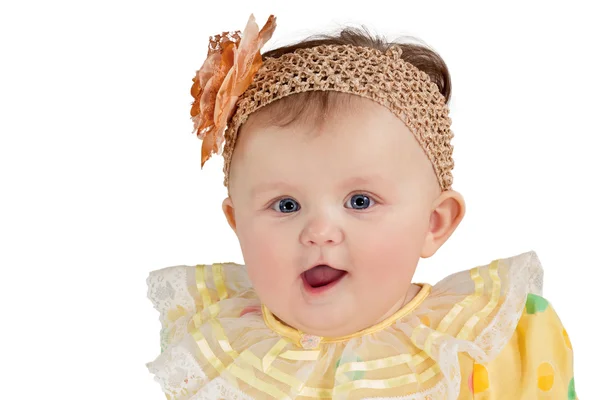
421;190;466;258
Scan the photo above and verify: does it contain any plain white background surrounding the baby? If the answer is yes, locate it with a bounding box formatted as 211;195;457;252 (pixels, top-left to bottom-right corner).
0;0;600;400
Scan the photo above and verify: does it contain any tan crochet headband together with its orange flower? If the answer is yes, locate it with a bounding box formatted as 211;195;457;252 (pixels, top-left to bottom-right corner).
191;15;454;191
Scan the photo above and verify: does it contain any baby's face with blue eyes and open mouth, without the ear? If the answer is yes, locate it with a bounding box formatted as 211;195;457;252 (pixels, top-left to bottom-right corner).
224;98;439;336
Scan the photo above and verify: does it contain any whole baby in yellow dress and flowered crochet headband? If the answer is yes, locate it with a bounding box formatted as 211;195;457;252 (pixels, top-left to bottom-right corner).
147;16;576;400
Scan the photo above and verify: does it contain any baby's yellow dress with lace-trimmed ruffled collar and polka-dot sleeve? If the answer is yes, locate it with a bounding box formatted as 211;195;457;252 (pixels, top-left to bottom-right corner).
146;252;577;400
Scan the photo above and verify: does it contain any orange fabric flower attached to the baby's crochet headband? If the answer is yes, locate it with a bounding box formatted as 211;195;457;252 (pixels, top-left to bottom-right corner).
190;15;276;167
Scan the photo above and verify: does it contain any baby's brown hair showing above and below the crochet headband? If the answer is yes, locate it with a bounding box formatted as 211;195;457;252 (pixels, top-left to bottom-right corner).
241;27;452;130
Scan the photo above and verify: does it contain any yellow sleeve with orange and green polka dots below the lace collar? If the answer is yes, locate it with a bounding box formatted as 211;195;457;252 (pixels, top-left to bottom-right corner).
470;294;577;400
